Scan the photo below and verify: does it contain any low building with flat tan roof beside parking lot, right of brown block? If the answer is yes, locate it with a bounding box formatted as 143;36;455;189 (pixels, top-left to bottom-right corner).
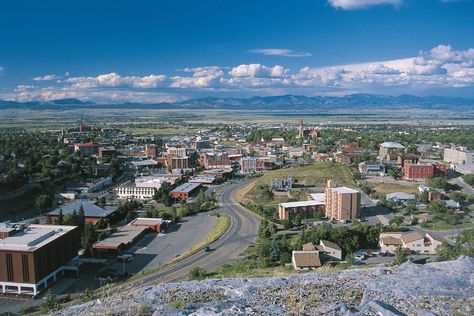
92;225;149;258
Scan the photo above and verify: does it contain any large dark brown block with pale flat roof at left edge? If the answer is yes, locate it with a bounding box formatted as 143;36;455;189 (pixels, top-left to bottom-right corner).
0;223;79;296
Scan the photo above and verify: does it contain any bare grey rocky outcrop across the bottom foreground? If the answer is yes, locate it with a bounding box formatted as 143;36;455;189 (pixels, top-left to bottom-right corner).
58;257;474;316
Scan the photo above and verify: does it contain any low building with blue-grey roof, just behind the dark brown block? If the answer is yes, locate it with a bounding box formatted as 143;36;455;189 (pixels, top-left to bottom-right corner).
47;200;117;224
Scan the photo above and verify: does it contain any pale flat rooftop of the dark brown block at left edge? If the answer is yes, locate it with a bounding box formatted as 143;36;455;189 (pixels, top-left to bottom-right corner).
0;225;76;251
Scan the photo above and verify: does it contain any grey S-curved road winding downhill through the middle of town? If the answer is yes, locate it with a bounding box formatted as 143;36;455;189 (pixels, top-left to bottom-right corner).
134;180;261;285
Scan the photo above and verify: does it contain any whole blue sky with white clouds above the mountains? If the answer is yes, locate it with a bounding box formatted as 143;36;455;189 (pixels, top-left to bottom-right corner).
0;0;474;102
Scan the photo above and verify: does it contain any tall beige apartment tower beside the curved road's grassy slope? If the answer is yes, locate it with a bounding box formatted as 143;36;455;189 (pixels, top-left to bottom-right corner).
325;181;360;221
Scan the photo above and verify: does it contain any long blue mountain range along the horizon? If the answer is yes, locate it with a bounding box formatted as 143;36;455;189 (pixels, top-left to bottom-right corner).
0;94;474;112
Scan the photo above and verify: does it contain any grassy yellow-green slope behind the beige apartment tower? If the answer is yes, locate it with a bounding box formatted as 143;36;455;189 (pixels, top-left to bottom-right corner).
244;162;356;203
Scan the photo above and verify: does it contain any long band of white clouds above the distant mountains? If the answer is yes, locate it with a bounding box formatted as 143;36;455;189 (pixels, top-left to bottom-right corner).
6;45;474;102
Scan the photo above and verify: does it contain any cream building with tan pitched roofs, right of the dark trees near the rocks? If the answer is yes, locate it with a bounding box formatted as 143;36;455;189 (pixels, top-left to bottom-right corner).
379;231;443;255
